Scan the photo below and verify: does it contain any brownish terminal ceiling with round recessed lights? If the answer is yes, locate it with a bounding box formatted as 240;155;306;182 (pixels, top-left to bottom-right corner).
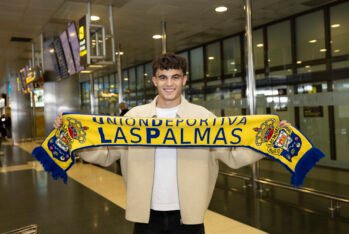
0;0;333;81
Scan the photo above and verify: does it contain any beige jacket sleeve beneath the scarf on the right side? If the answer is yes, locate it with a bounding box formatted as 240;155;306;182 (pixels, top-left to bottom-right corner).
211;147;264;169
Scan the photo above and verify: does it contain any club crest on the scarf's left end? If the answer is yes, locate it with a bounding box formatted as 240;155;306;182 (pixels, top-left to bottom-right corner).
48;118;88;162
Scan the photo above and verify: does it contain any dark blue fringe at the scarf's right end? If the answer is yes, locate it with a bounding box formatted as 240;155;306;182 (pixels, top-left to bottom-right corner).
291;147;325;187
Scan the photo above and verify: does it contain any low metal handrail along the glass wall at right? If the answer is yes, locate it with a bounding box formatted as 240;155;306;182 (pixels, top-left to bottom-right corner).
219;171;349;203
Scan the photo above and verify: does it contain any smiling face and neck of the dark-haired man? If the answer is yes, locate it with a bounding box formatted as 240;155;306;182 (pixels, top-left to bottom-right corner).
152;69;187;108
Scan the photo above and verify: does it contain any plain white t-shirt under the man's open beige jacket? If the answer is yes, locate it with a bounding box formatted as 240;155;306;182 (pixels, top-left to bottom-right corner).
151;106;179;211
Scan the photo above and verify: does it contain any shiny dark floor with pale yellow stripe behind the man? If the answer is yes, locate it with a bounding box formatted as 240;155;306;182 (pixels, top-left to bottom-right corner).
0;142;349;234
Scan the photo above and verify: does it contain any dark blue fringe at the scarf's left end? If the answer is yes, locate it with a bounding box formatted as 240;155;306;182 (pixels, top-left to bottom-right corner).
32;146;68;184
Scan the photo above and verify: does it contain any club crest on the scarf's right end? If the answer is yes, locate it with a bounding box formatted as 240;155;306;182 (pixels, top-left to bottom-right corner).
254;119;302;162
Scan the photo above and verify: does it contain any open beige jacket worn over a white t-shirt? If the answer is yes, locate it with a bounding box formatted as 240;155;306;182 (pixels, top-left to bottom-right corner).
79;97;263;224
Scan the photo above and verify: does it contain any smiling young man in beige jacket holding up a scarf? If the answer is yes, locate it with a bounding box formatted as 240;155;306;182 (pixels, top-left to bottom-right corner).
54;53;287;234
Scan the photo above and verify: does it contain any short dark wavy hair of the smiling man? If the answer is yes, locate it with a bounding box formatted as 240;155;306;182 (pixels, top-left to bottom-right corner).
153;53;187;76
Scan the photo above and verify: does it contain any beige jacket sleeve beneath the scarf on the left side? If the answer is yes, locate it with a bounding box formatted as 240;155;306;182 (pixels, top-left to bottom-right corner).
76;146;122;167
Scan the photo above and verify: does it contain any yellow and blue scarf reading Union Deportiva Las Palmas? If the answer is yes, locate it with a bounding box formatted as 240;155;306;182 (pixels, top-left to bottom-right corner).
33;114;324;186
